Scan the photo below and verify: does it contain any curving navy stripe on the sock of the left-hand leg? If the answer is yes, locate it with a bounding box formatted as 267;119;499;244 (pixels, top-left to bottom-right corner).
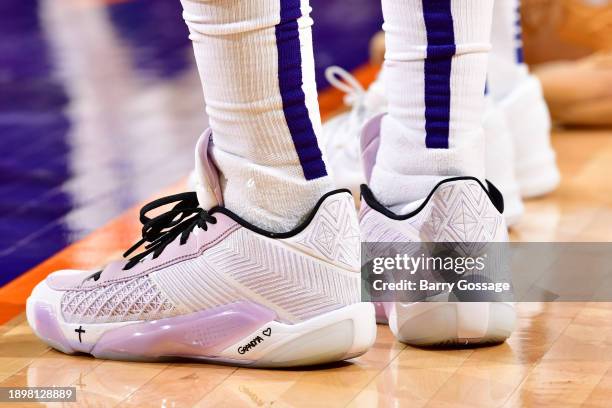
275;0;327;180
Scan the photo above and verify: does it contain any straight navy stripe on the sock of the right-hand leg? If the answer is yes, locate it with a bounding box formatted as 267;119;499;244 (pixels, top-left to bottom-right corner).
423;0;457;149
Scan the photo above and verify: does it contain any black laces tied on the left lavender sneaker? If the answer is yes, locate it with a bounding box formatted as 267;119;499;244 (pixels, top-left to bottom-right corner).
93;192;217;281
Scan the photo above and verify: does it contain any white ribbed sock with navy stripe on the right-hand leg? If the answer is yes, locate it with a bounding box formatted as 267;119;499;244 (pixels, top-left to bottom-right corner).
370;0;493;211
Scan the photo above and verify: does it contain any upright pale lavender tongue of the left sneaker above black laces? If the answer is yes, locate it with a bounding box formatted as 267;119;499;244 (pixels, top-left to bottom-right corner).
195;129;223;210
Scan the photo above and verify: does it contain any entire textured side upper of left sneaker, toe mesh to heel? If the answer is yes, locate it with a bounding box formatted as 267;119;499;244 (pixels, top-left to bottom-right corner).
61;193;360;323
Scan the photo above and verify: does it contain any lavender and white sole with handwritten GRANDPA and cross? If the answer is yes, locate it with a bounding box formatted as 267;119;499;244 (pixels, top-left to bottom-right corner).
27;292;376;367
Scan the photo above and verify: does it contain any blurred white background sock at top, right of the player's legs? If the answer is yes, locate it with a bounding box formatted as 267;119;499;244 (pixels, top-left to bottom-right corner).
488;0;528;101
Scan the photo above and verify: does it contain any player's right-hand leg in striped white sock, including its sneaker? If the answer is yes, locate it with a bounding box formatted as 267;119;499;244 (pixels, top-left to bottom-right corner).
360;0;515;345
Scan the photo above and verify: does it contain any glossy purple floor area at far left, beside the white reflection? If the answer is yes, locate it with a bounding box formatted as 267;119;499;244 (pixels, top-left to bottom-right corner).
0;0;73;286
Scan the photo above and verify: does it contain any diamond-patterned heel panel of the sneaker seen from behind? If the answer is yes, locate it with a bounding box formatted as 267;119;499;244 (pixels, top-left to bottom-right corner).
412;180;514;302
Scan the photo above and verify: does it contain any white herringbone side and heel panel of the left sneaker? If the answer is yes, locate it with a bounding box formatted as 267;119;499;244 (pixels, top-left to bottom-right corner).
153;194;360;322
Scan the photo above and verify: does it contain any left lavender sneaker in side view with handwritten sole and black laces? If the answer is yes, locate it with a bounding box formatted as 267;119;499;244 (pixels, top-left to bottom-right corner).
27;132;376;367
